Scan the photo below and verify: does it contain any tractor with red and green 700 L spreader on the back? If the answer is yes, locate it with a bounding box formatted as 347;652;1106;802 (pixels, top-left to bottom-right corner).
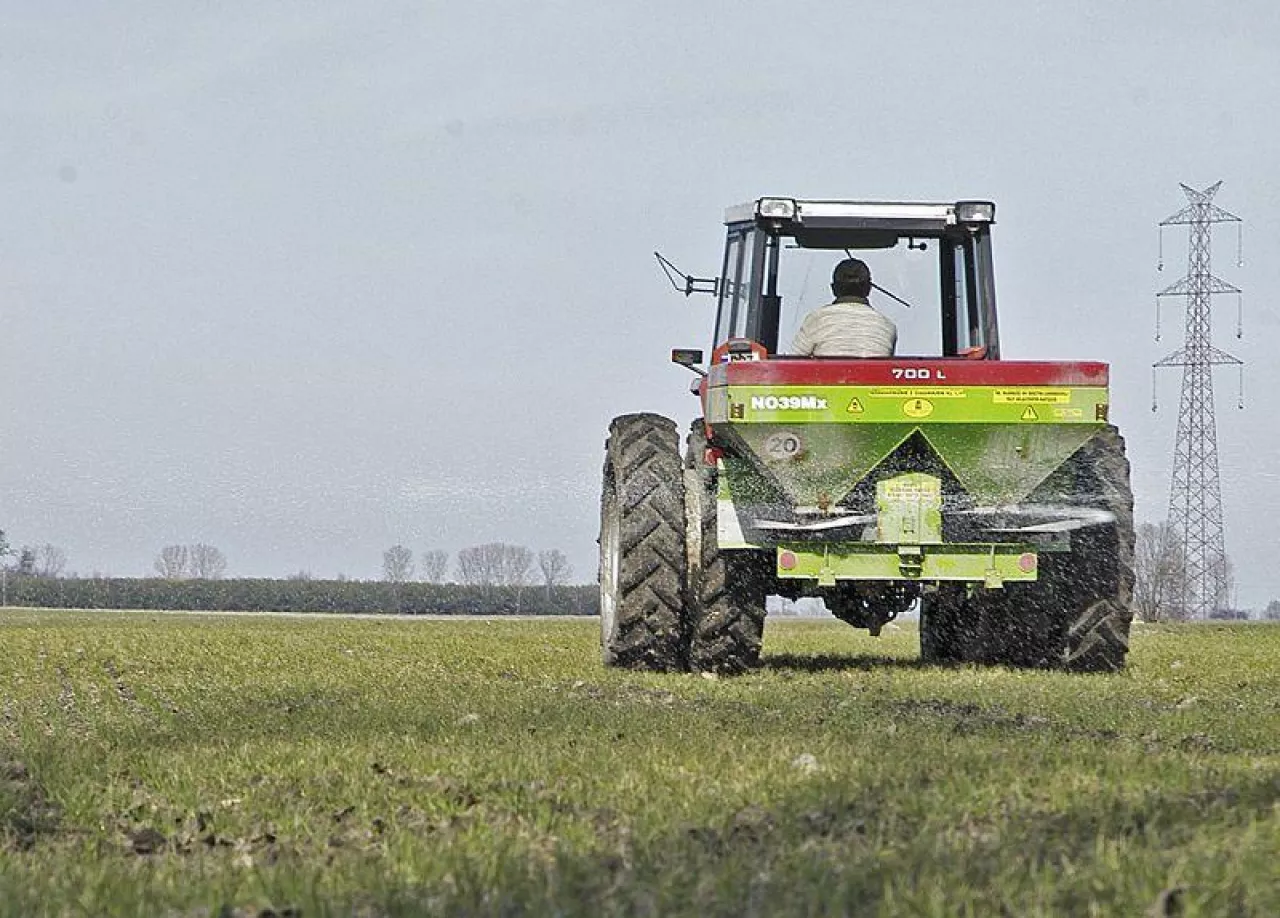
599;197;1134;673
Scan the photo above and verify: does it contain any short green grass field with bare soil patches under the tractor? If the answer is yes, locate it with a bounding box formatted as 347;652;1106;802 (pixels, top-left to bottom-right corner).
0;611;1280;918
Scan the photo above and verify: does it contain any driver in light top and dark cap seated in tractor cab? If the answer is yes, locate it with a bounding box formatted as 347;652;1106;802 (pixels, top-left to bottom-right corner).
791;259;897;357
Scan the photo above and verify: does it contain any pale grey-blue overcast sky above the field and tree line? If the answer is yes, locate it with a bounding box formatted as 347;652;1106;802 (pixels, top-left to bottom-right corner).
0;0;1280;607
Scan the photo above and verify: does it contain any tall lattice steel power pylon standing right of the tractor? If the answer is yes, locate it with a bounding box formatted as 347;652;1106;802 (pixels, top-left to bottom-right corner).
1152;182;1244;617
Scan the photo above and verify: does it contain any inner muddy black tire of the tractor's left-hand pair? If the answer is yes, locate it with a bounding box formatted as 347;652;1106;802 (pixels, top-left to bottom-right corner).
685;419;773;673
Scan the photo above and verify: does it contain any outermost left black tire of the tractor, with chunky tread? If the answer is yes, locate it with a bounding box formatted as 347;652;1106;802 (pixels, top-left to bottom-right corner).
600;415;687;671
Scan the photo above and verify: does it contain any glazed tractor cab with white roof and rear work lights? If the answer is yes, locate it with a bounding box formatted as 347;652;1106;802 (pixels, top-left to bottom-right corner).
709;197;1000;360
